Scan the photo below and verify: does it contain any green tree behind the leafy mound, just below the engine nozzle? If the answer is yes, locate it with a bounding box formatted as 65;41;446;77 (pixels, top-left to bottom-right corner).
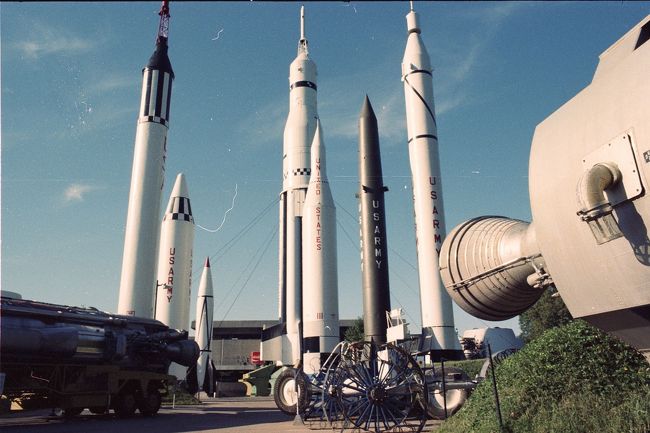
519;288;573;343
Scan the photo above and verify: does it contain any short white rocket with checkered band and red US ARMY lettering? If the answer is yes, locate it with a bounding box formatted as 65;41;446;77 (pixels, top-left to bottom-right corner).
155;173;194;330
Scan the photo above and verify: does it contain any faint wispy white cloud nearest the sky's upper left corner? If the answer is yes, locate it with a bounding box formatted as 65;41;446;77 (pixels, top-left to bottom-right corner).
13;23;94;60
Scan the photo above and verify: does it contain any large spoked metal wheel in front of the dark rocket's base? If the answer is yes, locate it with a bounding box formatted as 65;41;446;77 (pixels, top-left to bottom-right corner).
333;342;427;433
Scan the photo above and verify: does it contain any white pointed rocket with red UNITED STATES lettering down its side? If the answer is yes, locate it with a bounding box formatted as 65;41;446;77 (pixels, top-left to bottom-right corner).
302;120;340;374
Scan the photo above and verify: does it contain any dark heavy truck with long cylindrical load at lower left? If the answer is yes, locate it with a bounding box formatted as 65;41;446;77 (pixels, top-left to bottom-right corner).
0;292;199;417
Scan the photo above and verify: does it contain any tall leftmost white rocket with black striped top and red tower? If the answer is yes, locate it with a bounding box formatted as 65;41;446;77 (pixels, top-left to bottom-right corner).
117;1;174;318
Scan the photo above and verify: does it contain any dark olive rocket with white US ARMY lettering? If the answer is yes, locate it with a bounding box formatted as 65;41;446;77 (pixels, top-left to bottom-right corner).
354;96;390;344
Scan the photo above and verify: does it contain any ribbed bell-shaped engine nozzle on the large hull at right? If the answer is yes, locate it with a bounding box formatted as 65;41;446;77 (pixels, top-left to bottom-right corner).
440;216;551;320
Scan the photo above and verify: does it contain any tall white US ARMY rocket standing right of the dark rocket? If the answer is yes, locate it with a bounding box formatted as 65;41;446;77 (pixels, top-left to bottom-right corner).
402;3;462;359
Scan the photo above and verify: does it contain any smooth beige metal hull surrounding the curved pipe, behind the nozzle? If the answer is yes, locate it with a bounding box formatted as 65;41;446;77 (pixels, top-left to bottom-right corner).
530;17;650;317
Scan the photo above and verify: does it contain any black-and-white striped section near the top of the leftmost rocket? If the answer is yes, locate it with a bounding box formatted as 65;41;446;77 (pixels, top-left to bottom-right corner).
138;68;172;127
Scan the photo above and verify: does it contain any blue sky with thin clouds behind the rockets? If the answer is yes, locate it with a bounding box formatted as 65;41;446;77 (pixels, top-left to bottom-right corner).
0;1;650;331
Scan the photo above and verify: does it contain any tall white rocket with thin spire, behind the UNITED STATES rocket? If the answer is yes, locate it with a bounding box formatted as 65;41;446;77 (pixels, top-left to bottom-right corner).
279;6;318;365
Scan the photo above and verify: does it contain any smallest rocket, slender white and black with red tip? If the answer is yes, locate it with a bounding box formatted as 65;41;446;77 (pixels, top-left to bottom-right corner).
194;258;214;393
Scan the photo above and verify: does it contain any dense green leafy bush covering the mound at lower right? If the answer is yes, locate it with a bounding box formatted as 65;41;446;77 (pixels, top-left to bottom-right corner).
440;320;650;433
